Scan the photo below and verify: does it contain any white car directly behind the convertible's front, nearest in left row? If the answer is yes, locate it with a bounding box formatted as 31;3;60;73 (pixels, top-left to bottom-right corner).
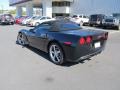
29;16;55;26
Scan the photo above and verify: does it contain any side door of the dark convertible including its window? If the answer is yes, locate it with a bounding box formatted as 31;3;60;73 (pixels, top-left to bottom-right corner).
30;24;50;51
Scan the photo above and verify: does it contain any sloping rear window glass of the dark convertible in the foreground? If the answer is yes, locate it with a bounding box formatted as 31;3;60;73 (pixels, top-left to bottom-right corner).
61;23;81;30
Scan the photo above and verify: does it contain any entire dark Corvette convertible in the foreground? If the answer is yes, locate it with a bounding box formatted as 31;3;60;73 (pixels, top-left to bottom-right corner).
17;20;108;65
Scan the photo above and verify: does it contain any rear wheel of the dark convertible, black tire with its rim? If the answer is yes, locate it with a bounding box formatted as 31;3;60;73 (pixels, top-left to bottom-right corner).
49;43;65;65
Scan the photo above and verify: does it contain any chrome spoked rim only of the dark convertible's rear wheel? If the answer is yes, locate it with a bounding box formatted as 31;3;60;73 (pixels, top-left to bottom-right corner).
49;45;63;63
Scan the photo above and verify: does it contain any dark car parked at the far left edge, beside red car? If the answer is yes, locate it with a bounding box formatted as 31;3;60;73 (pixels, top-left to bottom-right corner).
0;14;15;25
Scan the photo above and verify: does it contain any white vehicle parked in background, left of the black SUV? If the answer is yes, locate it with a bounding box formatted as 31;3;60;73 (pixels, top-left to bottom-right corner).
71;15;89;26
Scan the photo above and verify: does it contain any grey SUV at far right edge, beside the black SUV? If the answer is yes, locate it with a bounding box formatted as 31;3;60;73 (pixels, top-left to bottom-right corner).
102;17;120;30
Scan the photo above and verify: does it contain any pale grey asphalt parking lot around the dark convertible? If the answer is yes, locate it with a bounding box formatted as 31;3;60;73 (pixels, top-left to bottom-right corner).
0;25;120;90
